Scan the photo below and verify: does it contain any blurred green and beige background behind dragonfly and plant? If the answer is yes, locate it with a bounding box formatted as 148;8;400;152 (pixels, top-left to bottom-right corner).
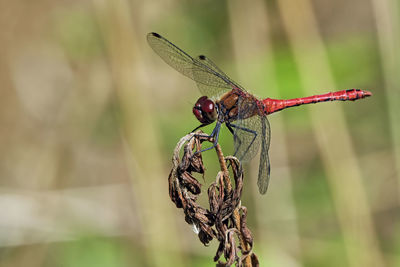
0;0;400;267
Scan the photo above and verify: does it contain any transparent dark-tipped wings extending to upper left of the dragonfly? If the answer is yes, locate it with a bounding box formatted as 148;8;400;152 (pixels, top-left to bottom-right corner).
147;32;236;97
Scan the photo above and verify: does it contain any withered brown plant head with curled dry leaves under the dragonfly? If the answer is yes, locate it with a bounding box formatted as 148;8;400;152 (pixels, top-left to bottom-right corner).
168;131;259;267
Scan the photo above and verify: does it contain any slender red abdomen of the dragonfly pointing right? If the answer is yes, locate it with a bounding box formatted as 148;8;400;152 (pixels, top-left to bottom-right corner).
262;89;372;115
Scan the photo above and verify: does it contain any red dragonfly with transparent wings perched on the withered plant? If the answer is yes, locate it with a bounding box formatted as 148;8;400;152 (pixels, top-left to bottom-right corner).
147;32;372;194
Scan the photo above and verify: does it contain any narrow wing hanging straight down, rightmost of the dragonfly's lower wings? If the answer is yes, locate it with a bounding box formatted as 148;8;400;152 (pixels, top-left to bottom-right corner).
257;116;271;194
